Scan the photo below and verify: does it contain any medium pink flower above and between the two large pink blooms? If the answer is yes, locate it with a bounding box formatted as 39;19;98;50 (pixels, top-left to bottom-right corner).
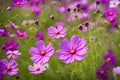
48;23;66;38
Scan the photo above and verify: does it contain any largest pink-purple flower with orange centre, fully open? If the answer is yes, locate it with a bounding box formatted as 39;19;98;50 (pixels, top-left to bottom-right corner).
57;35;88;64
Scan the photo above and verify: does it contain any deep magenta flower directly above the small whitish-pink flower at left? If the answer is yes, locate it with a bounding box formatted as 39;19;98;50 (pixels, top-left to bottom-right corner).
5;40;18;51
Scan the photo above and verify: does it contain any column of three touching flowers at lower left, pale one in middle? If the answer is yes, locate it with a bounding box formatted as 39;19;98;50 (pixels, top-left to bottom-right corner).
0;40;21;76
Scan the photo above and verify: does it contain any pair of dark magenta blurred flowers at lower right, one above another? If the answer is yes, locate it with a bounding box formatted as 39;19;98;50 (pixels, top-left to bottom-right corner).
96;50;116;80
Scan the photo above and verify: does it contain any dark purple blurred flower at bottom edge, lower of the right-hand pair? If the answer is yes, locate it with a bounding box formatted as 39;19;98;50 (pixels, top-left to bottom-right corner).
96;65;108;80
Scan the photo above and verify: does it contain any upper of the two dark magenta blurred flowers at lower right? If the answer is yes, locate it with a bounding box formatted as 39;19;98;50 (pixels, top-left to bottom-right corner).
104;50;116;66
